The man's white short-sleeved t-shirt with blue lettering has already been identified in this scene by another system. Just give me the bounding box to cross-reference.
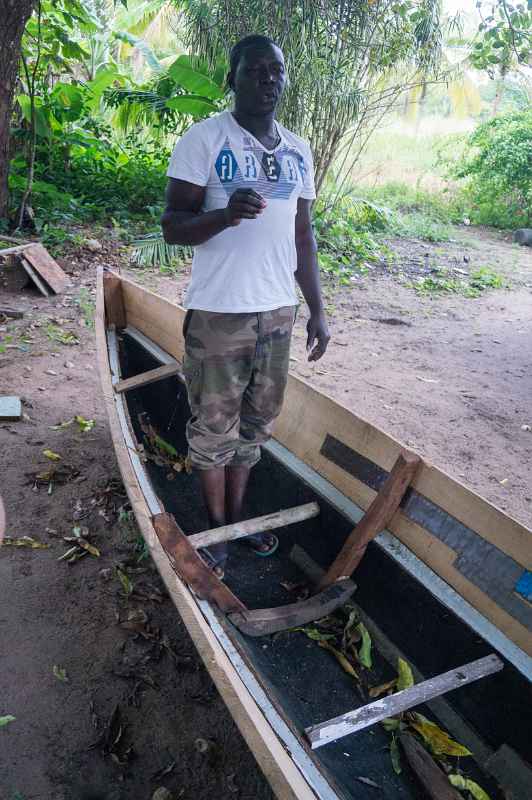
[167,111,316,314]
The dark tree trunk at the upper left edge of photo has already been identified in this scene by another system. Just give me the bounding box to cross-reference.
[0,0,35,219]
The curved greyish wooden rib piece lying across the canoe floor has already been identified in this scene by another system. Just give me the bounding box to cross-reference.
[229,579,357,636]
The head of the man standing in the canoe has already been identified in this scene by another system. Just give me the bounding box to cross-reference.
[227,34,286,115]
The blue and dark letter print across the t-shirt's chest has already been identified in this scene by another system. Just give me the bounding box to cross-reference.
[214,139,307,200]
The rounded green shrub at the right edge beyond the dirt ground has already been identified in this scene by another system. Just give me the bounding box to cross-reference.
[452,109,532,228]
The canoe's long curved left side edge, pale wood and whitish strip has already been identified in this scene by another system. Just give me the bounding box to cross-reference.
[95,269,339,800]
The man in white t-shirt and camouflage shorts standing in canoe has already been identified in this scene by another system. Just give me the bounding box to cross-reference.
[162,35,329,577]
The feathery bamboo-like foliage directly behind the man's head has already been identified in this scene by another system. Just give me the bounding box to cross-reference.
[183,0,442,189]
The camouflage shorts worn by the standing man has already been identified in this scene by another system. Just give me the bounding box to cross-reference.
[183,306,295,469]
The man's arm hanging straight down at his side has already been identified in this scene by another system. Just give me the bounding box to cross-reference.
[295,198,331,361]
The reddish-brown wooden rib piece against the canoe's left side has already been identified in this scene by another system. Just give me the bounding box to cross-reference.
[153,512,246,613]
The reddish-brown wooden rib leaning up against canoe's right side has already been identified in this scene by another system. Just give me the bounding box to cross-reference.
[319,450,422,588]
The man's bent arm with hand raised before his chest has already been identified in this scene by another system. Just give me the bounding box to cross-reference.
[161,178,266,246]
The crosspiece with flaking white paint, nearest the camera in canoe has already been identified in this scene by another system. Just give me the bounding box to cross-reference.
[305,654,504,750]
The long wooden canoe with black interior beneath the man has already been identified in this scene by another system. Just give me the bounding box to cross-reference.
[96,272,532,800]
